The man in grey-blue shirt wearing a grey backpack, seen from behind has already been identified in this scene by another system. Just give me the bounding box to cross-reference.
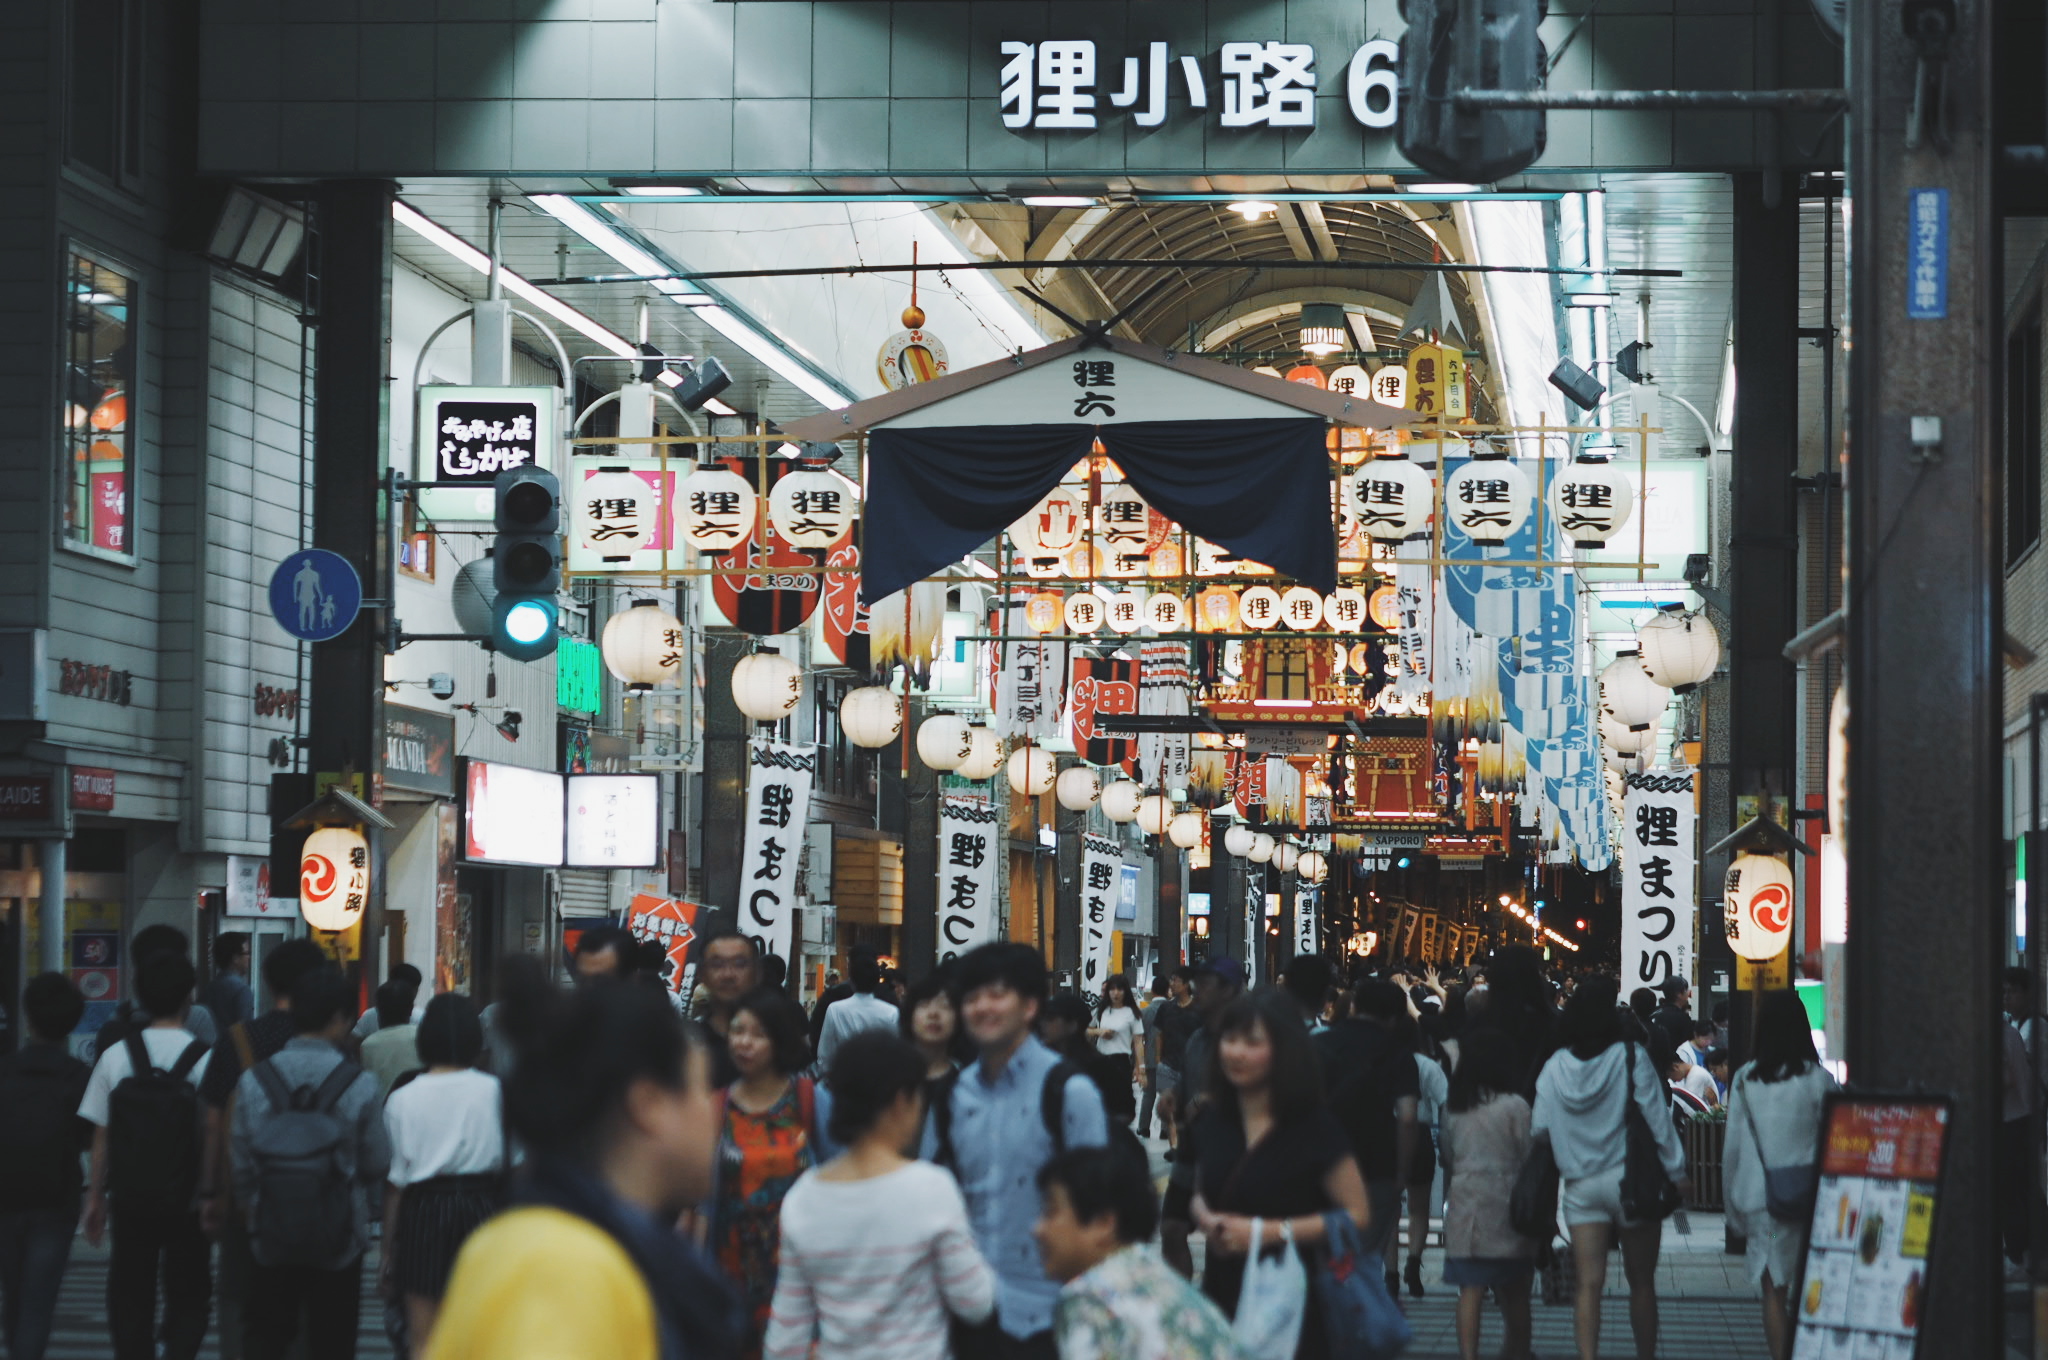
[229,965,391,1360]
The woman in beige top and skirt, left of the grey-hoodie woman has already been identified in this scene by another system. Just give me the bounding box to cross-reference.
[1442,1030,1538,1360]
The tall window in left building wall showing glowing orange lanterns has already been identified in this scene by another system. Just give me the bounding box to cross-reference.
[59,250,137,557]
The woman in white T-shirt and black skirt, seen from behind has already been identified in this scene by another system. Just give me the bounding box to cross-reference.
[381,991,512,1356]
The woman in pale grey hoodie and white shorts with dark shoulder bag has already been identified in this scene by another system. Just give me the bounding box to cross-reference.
[1530,977,1686,1360]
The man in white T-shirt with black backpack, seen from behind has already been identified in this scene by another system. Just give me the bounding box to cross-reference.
[78,950,213,1360]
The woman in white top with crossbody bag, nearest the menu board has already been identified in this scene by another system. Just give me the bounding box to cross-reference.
[1722,991,1835,1360]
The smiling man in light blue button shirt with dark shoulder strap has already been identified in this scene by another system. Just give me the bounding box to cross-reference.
[924,944,1110,1360]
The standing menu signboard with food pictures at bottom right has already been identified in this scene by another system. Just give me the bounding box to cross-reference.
[1792,1094,1950,1360]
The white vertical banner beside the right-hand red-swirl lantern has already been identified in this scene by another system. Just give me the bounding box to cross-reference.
[1622,770,1700,995]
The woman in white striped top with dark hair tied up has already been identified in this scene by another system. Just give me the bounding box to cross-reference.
[762,1030,995,1360]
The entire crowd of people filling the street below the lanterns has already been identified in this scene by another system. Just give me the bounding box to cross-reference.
[0,928,1831,1360]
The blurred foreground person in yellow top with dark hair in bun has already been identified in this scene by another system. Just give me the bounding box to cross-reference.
[426,959,745,1360]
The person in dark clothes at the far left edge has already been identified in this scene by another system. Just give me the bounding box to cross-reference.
[0,973,92,1360]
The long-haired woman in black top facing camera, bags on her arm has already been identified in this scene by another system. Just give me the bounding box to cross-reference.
[1190,993,1370,1360]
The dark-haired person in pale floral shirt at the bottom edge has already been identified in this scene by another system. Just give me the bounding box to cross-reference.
[1032,1139,1239,1360]
